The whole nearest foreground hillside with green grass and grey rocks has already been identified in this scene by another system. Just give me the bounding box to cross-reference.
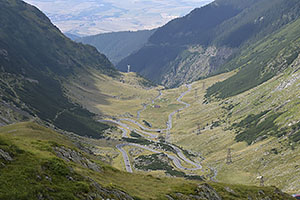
[0,123,292,200]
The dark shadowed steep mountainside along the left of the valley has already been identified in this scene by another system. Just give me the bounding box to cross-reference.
[0,0,118,137]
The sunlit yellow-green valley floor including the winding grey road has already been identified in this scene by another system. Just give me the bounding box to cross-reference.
[65,67,300,193]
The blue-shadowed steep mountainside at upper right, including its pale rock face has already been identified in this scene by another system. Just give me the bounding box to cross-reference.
[117,0,300,87]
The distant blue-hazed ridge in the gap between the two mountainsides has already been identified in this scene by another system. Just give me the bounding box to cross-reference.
[75,29,155,66]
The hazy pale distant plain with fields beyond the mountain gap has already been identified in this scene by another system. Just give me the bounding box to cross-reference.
[25,0,212,36]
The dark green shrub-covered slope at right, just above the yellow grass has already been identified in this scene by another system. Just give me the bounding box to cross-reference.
[206,14,300,99]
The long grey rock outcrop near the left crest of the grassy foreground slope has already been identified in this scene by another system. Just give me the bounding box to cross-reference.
[54,147,101,172]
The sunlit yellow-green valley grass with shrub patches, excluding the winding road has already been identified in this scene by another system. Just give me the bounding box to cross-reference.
[61,65,300,193]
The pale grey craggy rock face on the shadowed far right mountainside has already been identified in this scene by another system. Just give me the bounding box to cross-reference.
[162,45,233,87]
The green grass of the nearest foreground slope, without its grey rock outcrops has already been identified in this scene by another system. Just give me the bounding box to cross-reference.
[0,122,288,199]
